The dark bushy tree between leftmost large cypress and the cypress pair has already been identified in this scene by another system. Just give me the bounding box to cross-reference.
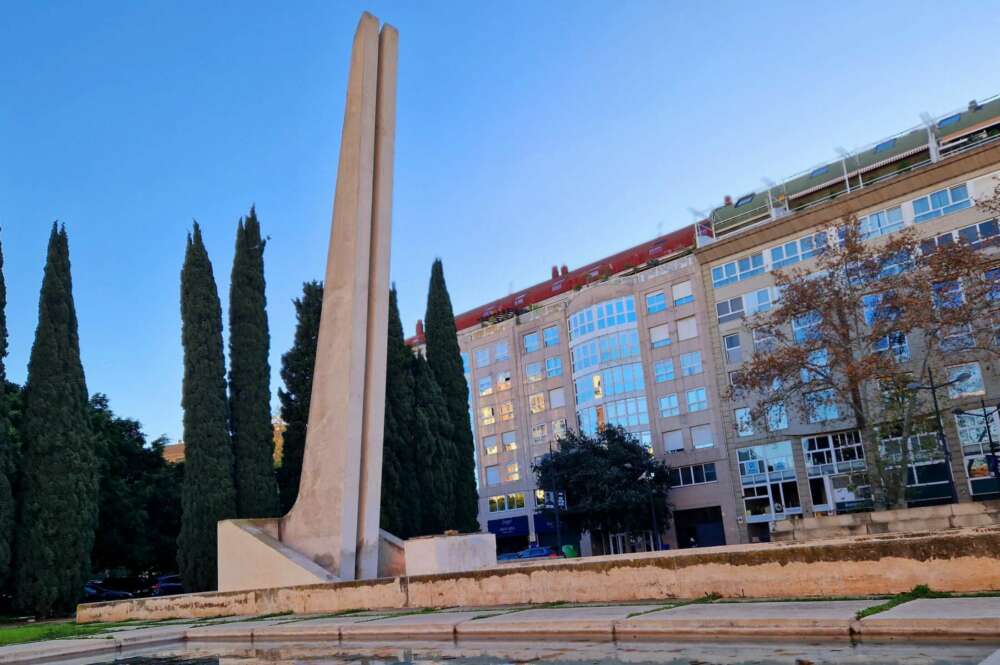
[90,393,180,575]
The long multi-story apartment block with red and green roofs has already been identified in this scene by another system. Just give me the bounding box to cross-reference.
[410,93,1000,552]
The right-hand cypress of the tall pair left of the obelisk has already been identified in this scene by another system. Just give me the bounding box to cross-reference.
[229,208,279,517]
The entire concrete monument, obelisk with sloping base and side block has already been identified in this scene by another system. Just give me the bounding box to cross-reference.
[218,12,496,591]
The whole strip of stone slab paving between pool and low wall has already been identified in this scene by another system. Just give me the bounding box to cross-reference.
[0,597,1000,663]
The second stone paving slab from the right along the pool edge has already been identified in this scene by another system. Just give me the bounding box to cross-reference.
[615,600,881,637]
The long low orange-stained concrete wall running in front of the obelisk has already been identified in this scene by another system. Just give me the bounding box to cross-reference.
[77,528,1000,623]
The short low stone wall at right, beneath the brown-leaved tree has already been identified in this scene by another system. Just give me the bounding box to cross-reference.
[772,501,1000,542]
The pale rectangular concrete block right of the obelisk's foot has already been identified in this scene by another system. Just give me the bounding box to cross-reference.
[406,533,497,576]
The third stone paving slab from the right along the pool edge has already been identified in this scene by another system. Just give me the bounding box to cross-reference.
[455,605,663,639]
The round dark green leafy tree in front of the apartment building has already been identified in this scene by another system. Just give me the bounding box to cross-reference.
[533,427,670,533]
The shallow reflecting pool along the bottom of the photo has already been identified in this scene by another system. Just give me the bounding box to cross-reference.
[74,641,1000,665]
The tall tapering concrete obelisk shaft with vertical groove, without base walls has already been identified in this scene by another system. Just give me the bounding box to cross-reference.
[279,12,399,580]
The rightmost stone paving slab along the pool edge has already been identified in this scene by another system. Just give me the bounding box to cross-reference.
[856,597,1000,639]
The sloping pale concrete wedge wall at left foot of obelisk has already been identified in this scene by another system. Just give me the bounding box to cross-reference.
[217,519,337,591]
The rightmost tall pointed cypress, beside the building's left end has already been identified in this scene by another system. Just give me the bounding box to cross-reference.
[424,259,479,532]
